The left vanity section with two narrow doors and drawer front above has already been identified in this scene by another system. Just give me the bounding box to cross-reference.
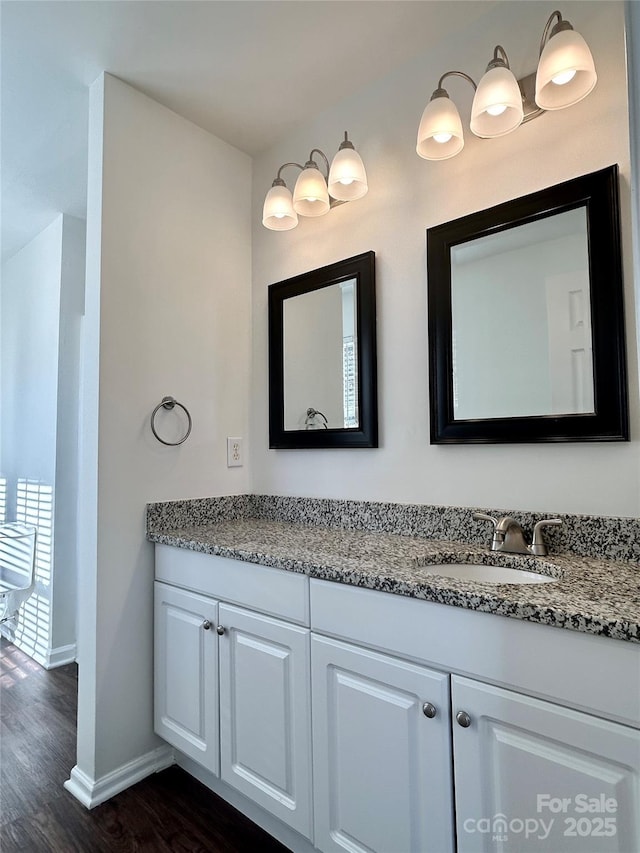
[155,546,312,838]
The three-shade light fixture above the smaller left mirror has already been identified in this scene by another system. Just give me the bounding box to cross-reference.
[262,131,369,231]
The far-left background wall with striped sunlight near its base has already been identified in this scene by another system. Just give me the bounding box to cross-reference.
[0,215,84,667]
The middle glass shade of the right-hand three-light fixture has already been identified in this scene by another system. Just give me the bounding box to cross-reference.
[470,65,524,139]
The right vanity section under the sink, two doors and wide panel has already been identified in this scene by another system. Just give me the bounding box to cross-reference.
[311,580,640,853]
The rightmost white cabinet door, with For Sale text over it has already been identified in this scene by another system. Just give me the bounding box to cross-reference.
[451,662,640,853]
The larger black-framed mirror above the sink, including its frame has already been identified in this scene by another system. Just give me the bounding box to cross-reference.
[427,166,629,444]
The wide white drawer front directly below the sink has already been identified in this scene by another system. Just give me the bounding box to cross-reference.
[310,579,640,728]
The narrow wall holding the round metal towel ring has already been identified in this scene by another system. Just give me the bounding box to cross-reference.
[75,75,251,795]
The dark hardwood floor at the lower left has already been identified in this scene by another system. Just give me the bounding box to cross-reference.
[0,639,287,853]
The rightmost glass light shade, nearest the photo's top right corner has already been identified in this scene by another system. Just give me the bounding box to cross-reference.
[536,30,598,110]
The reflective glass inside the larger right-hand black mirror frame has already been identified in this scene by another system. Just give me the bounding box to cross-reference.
[451,206,594,420]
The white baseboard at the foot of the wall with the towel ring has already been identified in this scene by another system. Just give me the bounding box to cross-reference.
[64,746,175,809]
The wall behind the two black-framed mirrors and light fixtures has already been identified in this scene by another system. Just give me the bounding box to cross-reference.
[251,2,640,516]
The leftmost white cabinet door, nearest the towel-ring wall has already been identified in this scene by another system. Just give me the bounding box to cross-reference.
[154,582,219,776]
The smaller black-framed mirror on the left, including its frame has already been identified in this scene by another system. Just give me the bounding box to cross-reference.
[269,252,378,449]
